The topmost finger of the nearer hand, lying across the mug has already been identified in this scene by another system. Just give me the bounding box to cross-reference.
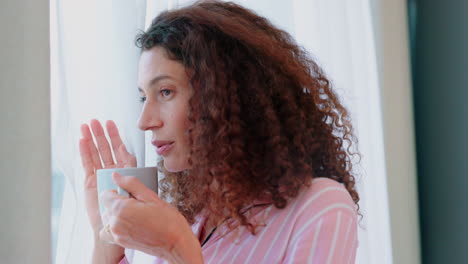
[112,172,160,202]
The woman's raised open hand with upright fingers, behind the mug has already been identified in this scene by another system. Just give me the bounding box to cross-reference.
[80,119,137,236]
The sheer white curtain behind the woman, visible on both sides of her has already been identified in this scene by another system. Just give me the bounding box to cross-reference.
[51,0,392,264]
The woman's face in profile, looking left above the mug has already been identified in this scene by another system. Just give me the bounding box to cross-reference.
[138,47,193,172]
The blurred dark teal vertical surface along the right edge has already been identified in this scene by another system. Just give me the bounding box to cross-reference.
[408,0,468,264]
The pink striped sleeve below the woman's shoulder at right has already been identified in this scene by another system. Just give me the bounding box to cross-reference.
[284,209,357,264]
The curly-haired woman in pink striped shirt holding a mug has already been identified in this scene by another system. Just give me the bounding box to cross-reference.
[80,1,359,263]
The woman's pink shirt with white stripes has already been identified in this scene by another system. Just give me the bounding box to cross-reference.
[119,178,358,264]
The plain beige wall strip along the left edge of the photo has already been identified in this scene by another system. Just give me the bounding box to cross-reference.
[0,0,51,264]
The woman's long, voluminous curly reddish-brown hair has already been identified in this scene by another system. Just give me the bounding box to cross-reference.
[136,1,359,234]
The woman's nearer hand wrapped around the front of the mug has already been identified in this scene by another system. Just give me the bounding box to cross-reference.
[100,172,203,263]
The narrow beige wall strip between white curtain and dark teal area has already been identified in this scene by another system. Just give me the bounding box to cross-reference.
[370,0,421,264]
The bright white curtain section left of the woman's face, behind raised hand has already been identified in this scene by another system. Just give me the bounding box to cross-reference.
[51,0,146,263]
